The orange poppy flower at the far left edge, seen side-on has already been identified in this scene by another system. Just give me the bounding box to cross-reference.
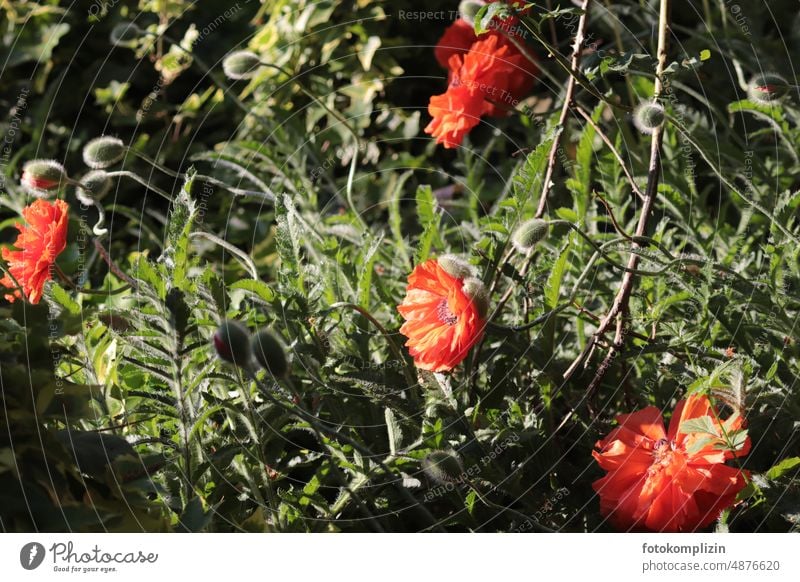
[0,200,69,303]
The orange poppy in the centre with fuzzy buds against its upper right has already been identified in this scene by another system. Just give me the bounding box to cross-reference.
[397,256,488,372]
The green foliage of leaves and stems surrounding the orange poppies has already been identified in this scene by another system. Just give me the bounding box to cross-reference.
[0,0,800,532]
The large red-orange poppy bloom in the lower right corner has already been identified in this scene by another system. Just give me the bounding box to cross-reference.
[592,394,750,532]
